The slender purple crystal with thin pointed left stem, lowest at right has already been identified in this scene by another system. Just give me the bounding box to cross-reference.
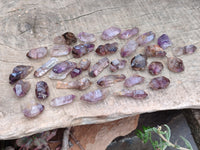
[115,89,148,99]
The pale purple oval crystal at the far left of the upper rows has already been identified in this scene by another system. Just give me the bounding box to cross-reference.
[26,47,47,59]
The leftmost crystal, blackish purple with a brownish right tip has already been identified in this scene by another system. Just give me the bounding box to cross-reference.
[9,65,33,84]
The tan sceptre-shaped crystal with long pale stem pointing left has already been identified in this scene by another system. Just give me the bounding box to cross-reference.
[56,78,92,90]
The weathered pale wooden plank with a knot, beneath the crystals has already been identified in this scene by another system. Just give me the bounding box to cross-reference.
[0,0,200,139]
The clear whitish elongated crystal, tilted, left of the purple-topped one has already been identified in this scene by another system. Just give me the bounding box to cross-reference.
[34,57,58,77]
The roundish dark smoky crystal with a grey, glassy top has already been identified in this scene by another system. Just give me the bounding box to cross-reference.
[131,54,147,71]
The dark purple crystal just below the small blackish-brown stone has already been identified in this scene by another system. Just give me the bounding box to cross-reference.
[72,43,95,58]
